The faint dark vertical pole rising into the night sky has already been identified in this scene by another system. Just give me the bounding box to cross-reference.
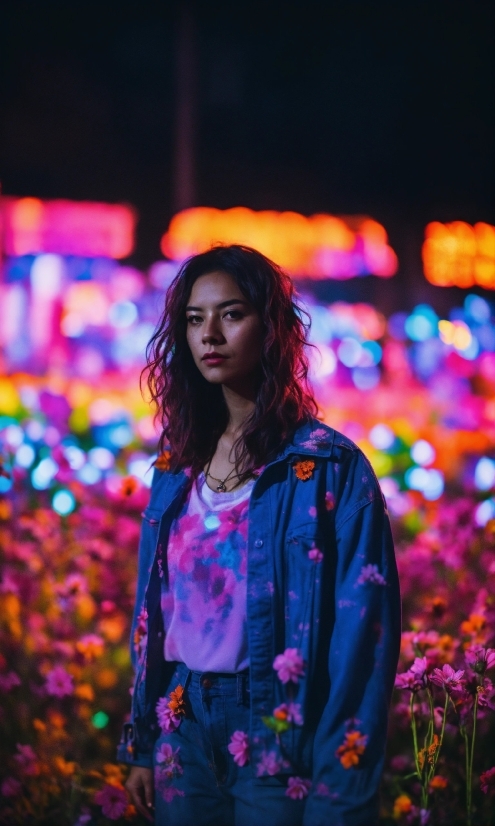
[173,0,196,212]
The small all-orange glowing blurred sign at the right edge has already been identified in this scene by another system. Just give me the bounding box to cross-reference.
[423,221,495,290]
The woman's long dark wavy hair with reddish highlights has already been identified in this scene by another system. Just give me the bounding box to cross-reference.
[142,244,317,476]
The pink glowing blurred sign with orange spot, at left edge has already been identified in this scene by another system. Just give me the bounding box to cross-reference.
[1,198,136,258]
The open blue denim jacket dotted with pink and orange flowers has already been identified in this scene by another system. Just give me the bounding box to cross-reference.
[118,420,400,826]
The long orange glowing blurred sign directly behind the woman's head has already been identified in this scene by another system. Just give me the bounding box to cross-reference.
[161,207,397,279]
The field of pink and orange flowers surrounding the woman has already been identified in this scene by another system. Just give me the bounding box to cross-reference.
[0,292,495,826]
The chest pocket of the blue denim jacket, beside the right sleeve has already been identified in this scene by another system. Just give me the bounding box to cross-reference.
[285,523,323,652]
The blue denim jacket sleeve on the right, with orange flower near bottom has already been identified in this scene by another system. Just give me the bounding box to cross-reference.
[303,454,401,826]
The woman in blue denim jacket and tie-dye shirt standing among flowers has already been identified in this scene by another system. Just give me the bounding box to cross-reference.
[119,245,400,826]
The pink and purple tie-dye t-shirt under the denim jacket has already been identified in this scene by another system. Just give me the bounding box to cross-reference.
[162,474,254,673]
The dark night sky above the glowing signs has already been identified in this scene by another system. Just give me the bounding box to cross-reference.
[0,0,495,308]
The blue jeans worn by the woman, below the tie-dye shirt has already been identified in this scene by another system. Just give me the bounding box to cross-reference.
[153,663,304,826]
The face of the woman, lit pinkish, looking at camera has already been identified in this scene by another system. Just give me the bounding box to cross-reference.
[186,270,263,393]
